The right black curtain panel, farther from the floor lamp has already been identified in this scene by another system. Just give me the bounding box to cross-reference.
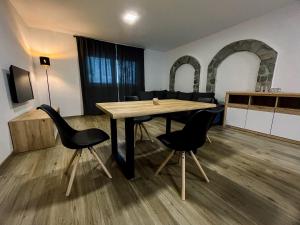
[117,45,145,101]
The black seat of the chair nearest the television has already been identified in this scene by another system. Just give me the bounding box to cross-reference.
[72,128,109,149]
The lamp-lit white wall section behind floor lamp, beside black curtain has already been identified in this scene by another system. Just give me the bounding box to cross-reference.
[28,28,83,116]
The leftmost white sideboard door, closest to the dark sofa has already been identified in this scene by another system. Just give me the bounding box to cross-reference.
[226,107,248,128]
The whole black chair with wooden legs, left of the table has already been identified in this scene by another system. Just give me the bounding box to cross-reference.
[37,104,112,197]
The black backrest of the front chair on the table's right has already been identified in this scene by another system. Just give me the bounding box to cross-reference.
[182,110,216,149]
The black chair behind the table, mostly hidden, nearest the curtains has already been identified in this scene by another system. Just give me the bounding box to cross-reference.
[125,96,153,143]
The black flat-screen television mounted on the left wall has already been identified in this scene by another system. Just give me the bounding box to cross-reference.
[8,65,34,103]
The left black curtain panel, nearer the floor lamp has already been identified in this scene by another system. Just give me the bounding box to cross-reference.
[76,36,118,115]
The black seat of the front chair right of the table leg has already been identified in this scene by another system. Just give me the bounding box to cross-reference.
[157,130,191,151]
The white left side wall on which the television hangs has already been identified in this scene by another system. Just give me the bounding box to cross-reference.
[0,1,38,163]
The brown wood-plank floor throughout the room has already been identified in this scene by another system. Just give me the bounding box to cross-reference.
[0,116,300,225]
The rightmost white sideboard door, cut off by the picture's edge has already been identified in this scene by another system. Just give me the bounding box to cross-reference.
[271,113,300,141]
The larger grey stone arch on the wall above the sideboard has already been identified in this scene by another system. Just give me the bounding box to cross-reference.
[206,39,277,92]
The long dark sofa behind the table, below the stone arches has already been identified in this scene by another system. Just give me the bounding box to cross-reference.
[138,90,224,124]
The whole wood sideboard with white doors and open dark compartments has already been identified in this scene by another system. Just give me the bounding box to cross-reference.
[224,92,300,144]
